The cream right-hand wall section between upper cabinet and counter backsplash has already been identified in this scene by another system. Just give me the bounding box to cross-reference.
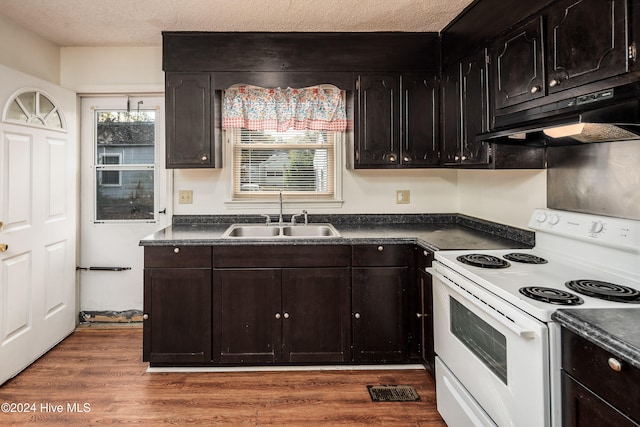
[458,170,547,229]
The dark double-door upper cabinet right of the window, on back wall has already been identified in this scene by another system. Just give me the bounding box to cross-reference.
[355,73,438,168]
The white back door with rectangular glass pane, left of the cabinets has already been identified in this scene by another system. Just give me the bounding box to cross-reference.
[80,96,171,314]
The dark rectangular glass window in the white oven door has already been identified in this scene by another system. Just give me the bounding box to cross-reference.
[449,296,507,385]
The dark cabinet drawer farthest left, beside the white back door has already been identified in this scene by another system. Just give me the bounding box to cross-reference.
[144,246,211,268]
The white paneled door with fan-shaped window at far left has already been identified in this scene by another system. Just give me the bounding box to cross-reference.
[0,67,77,384]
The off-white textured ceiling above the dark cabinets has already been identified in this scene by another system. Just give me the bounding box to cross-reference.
[0,0,472,47]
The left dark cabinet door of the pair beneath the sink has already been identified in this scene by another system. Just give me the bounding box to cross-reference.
[213,268,282,364]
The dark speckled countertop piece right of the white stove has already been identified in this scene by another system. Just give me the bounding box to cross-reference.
[551,308,640,369]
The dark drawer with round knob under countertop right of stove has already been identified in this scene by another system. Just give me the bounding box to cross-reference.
[562,328,640,422]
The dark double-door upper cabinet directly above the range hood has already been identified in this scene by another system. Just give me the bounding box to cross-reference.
[490,0,635,122]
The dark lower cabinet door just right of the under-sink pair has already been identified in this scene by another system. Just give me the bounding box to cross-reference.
[351,267,408,362]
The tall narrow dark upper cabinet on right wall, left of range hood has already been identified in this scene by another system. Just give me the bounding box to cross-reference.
[441,49,489,166]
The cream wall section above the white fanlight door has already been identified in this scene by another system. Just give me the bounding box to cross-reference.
[0,15,60,84]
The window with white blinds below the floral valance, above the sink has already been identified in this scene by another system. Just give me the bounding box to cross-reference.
[226,129,343,200]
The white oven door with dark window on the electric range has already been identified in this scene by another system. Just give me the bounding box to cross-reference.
[429,262,550,427]
